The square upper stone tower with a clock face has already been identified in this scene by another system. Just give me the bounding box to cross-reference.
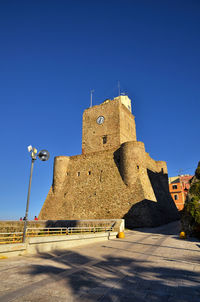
[82,95,136,154]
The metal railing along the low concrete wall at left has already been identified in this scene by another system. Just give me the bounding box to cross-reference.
[0,227,114,244]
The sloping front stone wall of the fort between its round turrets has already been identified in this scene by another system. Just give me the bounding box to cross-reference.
[39,150,142,219]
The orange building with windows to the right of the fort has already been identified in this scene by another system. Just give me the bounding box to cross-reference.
[169,175,193,211]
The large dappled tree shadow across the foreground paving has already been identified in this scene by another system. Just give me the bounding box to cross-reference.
[22,247,200,302]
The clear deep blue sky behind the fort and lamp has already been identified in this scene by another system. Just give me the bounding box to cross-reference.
[0,0,200,219]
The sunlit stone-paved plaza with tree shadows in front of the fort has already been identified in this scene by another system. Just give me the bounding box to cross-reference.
[0,222,200,302]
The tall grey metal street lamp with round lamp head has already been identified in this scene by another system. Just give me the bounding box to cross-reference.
[23,145,49,242]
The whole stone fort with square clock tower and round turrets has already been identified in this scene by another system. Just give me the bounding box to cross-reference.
[39,95,178,227]
